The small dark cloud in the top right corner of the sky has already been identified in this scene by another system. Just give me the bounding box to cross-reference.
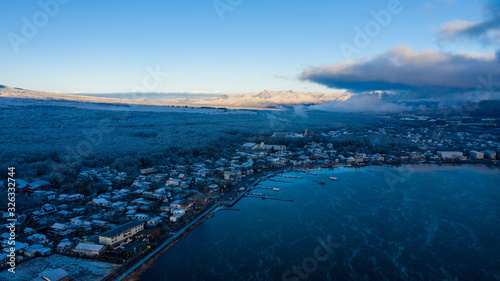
[440,0,500,44]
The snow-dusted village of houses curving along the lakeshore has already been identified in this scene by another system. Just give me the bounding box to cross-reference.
[0,118,500,280]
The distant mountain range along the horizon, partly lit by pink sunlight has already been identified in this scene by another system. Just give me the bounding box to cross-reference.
[0,85,500,117]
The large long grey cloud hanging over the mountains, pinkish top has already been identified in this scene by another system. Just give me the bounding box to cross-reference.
[300,46,500,93]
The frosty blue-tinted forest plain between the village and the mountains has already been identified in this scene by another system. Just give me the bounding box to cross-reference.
[0,103,398,186]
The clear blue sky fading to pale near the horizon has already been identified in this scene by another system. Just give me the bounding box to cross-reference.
[0,0,495,93]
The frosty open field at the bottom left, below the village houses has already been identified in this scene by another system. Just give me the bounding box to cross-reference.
[0,255,119,281]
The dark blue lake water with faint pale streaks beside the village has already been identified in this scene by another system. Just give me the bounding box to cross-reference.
[140,165,500,281]
